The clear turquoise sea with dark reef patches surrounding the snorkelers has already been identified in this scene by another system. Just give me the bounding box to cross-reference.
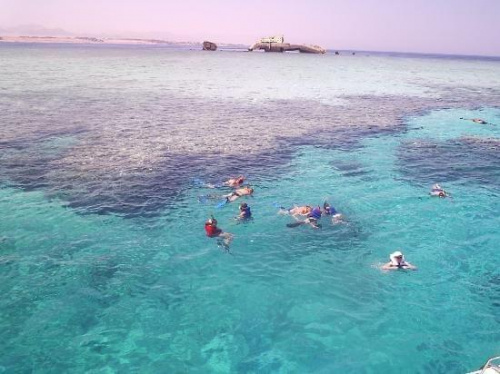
[0,43,500,374]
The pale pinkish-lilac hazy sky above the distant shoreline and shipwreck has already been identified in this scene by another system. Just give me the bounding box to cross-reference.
[0,0,500,56]
